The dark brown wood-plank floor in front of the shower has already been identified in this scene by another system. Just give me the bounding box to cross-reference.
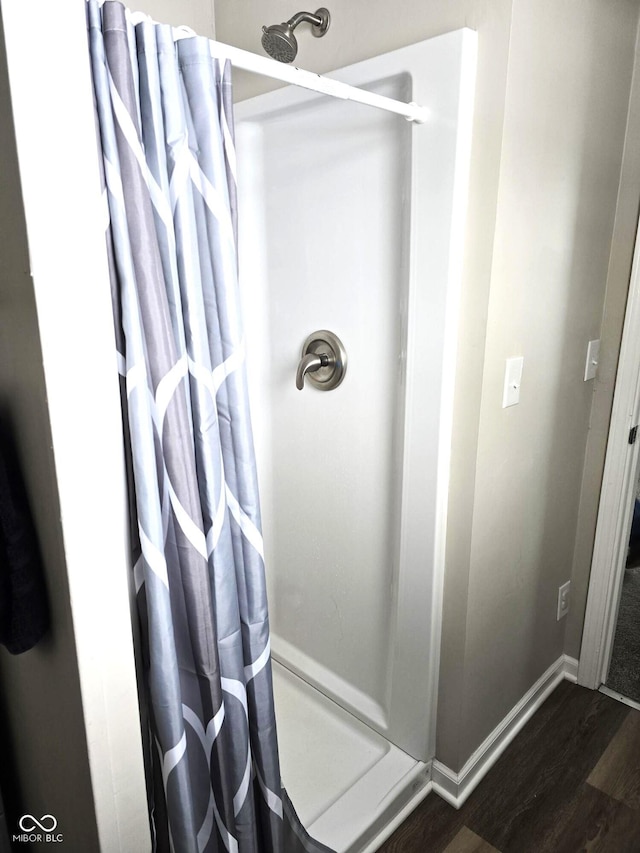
[380,681,640,853]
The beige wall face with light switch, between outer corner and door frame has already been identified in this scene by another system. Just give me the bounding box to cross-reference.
[458,0,638,761]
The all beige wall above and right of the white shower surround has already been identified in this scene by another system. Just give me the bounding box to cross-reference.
[216,0,638,770]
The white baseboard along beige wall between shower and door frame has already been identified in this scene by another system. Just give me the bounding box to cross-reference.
[431,655,578,809]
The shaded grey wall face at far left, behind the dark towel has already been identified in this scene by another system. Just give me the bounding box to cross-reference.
[0,22,97,850]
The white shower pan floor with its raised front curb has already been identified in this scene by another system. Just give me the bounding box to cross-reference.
[273,661,431,853]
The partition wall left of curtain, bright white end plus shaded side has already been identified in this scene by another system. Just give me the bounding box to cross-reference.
[0,0,150,853]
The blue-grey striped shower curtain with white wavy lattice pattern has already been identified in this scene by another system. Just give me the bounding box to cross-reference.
[87,0,336,853]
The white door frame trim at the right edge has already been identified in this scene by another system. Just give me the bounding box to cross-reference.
[578,216,640,689]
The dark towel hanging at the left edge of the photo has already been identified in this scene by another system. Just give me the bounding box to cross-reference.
[0,422,49,655]
